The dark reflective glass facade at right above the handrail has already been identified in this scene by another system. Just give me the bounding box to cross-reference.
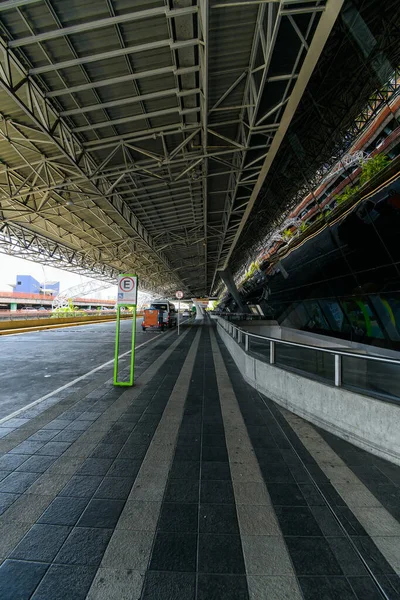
[241,176,400,350]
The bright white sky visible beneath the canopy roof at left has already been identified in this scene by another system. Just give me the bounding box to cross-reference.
[0,254,117,300]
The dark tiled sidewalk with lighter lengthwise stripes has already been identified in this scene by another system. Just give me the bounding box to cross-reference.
[0,322,400,600]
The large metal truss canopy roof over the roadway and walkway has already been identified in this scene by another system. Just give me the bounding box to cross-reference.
[0,0,342,296]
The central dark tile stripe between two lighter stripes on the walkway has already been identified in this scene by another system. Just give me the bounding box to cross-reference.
[142,328,249,600]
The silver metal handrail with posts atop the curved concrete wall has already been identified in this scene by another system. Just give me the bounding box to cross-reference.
[218,317,400,387]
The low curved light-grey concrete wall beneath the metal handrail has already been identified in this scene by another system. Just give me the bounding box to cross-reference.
[218,326,400,465]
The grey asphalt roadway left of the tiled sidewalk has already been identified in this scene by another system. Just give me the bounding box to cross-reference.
[0,319,160,419]
